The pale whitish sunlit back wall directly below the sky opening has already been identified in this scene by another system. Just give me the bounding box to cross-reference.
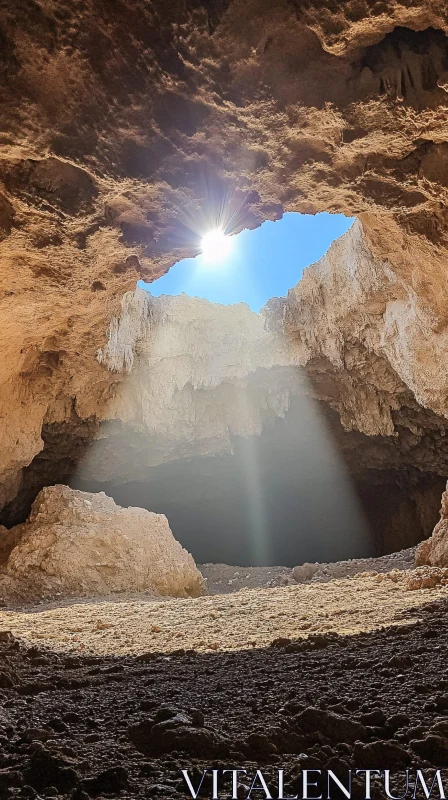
[89,289,296,472]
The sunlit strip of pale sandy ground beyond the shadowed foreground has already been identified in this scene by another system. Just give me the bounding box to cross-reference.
[0,571,448,656]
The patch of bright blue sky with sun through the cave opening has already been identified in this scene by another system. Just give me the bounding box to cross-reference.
[138,213,353,311]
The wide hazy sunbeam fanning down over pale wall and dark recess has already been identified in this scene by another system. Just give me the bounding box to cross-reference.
[72,282,372,566]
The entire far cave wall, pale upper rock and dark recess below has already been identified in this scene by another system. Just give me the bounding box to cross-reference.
[1,223,448,564]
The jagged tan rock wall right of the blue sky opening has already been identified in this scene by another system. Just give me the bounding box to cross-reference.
[263,221,448,436]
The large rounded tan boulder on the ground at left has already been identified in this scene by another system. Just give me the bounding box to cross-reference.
[0,486,203,600]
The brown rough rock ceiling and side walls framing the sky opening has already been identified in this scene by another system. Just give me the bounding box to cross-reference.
[0,0,448,564]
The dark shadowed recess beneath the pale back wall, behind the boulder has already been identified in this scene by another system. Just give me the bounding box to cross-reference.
[0,397,445,566]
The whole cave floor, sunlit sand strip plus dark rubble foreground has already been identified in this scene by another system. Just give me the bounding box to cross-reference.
[0,568,448,800]
